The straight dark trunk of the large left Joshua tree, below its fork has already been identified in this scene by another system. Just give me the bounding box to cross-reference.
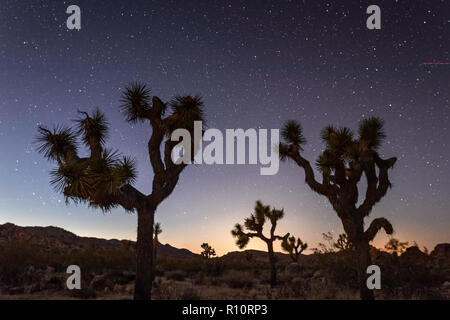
[134,206,155,300]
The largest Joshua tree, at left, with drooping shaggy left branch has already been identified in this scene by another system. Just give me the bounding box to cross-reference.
[37,83,203,300]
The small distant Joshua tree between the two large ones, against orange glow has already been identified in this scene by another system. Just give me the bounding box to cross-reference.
[231,201,289,287]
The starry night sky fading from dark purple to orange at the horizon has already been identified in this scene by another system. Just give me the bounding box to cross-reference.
[0,0,450,255]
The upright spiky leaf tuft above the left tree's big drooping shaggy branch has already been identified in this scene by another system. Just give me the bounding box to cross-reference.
[75,108,108,146]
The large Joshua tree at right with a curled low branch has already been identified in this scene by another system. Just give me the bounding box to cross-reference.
[279,118,397,299]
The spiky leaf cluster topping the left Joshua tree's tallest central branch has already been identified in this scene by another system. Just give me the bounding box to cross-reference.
[121,82,151,123]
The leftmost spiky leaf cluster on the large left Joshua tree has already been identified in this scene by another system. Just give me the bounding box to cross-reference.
[35,126,77,162]
